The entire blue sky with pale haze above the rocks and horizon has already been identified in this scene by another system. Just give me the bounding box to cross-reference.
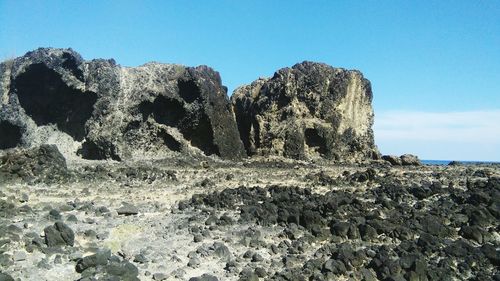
[0,0,500,161]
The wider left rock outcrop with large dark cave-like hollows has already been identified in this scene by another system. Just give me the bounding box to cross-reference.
[0,48,244,160]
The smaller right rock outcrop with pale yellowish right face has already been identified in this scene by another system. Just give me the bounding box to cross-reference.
[231,62,379,161]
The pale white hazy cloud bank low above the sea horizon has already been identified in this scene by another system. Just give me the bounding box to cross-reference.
[374,110,500,161]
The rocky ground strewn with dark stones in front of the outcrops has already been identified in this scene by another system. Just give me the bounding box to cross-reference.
[0,146,500,281]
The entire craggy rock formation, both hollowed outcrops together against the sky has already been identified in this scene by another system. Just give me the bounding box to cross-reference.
[0,48,379,161]
